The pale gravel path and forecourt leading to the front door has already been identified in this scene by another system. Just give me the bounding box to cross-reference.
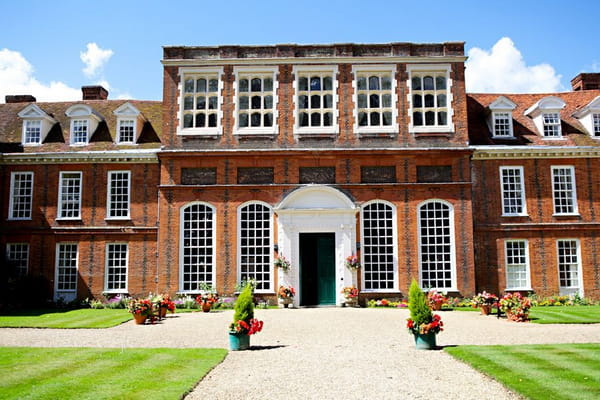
[0,308,600,400]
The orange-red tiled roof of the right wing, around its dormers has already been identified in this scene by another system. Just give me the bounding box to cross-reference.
[467,90,600,146]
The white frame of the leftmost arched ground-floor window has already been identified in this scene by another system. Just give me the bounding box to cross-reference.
[178,201,217,293]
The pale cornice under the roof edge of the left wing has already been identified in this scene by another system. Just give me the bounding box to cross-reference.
[0,149,159,164]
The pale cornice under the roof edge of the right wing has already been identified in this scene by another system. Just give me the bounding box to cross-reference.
[471,146,600,160]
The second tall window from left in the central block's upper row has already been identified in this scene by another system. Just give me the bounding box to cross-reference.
[236,69,277,133]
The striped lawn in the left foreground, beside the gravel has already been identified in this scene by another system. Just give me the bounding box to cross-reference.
[0,347,227,399]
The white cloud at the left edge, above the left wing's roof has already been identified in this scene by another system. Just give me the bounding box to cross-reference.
[0,49,81,103]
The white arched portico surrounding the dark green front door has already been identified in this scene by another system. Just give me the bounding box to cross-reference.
[274,185,359,307]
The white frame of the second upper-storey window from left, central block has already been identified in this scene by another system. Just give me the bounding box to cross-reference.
[233,66,279,136]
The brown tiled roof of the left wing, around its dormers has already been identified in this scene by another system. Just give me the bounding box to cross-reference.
[0,100,162,153]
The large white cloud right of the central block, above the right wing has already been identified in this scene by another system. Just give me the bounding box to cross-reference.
[465,37,563,93]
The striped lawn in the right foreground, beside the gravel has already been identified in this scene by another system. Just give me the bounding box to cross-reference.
[444,343,600,400]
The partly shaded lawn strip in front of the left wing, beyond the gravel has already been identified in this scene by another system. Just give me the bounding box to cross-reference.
[0,308,132,328]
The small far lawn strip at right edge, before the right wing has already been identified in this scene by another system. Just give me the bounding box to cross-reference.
[529,306,600,324]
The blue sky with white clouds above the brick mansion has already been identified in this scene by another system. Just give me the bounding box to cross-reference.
[0,0,600,101]
